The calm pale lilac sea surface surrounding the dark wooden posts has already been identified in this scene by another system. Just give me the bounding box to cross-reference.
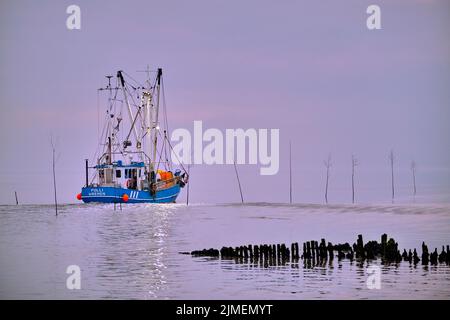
[0,203,450,299]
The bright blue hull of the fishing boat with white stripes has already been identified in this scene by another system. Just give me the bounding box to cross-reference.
[81,184,180,203]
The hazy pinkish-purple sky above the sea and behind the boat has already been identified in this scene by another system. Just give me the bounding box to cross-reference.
[0,0,450,204]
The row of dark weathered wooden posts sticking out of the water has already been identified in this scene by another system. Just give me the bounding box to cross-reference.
[182,234,450,266]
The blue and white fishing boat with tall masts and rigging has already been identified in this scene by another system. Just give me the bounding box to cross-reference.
[77,68,189,203]
